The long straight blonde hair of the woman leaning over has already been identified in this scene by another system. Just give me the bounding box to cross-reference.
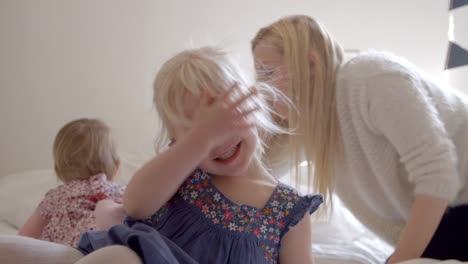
[252,15,343,205]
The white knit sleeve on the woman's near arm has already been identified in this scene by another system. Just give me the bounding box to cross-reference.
[365,72,460,202]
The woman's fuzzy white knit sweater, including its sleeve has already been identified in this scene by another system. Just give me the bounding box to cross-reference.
[335,52,468,244]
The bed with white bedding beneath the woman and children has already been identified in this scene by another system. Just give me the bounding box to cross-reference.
[0,164,459,264]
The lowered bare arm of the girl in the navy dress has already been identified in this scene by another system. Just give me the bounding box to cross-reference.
[279,213,314,264]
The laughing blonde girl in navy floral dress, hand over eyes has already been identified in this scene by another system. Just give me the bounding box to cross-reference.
[0,47,322,264]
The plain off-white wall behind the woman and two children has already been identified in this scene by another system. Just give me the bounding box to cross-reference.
[0,0,448,175]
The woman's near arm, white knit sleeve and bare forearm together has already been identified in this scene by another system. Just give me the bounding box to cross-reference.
[366,74,461,263]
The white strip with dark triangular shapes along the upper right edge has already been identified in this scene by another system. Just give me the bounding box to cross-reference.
[445,0,468,93]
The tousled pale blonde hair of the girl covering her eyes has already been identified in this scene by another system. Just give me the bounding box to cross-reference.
[153,47,284,162]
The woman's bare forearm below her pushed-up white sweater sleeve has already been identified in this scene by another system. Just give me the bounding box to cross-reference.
[388,194,447,263]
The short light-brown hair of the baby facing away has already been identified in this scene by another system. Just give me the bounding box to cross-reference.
[53,118,119,182]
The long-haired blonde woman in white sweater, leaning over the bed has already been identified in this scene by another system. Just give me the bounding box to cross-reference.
[252,16,468,263]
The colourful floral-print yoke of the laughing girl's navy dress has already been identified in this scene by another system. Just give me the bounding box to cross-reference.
[152,170,314,263]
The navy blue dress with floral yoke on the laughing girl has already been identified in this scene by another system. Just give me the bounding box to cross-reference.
[78,169,322,264]
